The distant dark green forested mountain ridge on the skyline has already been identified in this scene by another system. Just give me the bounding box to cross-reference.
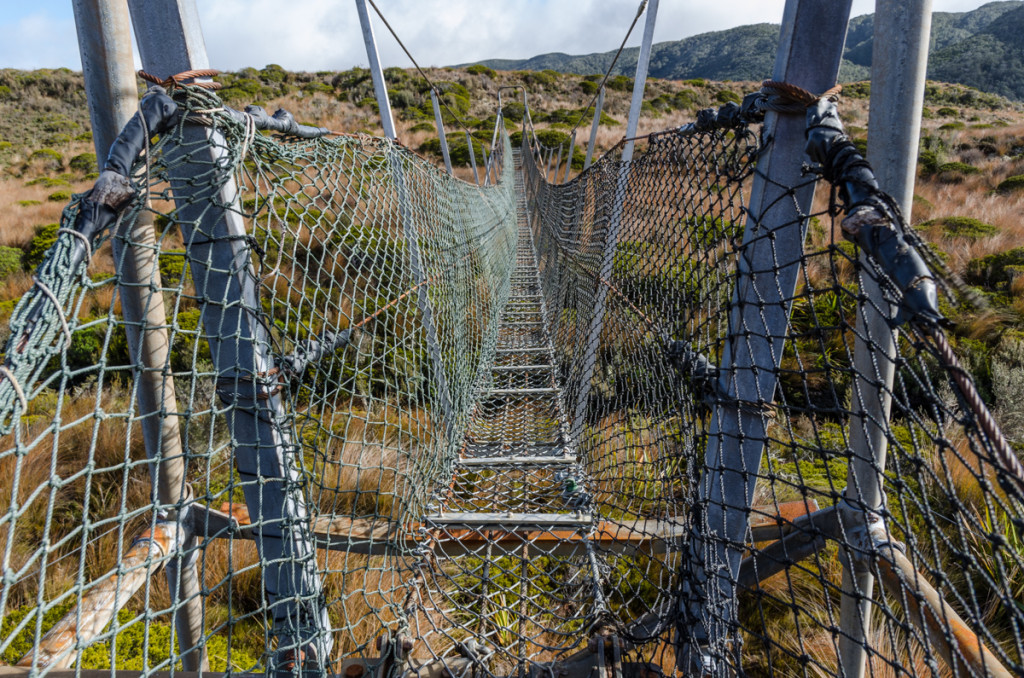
[463,0,1024,100]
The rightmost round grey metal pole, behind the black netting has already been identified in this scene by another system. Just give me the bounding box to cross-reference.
[839,0,932,678]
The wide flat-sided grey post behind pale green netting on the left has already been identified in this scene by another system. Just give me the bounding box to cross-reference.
[123,0,332,670]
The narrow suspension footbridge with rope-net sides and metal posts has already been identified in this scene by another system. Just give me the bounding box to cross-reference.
[0,0,1024,678]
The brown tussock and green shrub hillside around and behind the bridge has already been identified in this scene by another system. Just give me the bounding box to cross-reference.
[0,65,1024,670]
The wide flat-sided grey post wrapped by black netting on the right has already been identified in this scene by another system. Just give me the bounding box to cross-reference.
[679,0,852,672]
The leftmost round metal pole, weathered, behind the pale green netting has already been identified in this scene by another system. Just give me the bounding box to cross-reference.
[72,0,209,671]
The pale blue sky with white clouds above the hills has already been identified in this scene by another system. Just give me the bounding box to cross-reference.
[0,0,1003,71]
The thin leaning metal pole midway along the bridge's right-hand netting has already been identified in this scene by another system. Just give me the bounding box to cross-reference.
[571,0,658,440]
